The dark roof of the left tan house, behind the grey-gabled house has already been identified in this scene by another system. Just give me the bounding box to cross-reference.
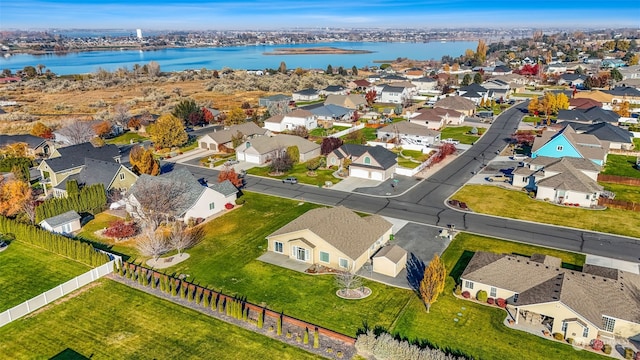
[43,142,120,172]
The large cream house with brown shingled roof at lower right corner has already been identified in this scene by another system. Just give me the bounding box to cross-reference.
[460,251,640,345]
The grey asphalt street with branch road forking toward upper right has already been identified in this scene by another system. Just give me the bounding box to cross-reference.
[177,103,640,262]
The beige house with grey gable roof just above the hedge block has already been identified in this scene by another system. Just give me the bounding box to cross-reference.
[53,158,138,197]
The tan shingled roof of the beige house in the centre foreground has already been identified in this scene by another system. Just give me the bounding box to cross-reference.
[267,206,393,259]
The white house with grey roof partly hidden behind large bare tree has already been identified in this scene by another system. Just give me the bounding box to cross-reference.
[125,167,238,223]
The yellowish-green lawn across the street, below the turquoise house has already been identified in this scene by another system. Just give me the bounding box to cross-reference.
[452,185,640,237]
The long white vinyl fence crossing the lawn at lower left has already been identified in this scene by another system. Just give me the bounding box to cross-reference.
[0,256,120,327]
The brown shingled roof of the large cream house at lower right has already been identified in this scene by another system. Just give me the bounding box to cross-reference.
[461,251,640,327]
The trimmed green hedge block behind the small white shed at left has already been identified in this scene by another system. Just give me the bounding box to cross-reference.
[36,181,107,223]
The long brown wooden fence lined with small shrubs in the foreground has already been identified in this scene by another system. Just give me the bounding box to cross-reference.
[123,262,356,346]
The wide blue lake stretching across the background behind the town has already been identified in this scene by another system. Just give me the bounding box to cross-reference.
[0,41,477,75]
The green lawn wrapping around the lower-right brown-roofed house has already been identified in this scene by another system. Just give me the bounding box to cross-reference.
[390,233,603,360]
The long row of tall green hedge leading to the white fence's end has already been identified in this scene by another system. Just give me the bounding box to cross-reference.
[0,216,109,267]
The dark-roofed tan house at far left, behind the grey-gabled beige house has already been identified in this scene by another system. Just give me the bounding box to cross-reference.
[38,142,121,194]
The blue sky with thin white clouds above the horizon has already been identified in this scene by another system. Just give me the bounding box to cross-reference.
[0,0,640,30]
